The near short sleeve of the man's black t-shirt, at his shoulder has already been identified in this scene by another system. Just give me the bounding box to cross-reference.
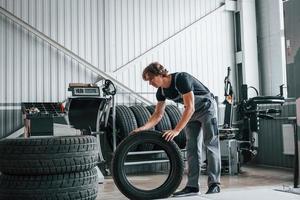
[176,72,194,94]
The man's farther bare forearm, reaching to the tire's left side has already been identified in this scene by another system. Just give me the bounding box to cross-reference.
[132,101,166,132]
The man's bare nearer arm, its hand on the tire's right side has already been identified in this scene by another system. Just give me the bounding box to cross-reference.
[163,91,195,141]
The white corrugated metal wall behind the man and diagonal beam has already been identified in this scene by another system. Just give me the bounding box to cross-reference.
[0,0,234,137]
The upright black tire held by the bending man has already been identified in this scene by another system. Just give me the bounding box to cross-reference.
[112,131,184,199]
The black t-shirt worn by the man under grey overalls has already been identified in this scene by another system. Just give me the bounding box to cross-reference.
[156,72,210,103]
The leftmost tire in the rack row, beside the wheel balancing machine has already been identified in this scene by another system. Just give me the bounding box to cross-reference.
[107,105,138,149]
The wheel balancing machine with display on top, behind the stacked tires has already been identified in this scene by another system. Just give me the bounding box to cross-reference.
[65,79,116,177]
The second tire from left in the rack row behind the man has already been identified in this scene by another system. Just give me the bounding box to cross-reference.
[130,105,154,151]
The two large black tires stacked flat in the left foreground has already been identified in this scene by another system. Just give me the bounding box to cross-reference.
[0,136,99,200]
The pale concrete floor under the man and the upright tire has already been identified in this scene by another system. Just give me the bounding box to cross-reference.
[97,166,300,200]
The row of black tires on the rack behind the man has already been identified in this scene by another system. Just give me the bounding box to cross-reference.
[108,105,186,151]
